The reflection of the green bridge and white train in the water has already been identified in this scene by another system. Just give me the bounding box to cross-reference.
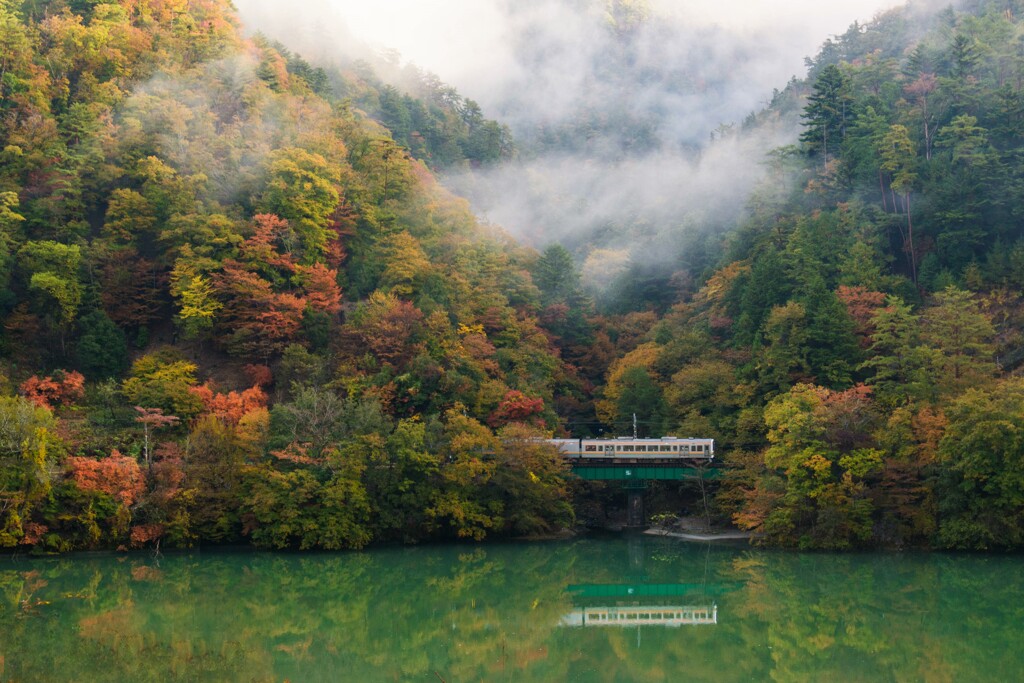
[559,584,718,628]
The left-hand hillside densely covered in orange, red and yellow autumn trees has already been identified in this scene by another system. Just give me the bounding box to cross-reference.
[0,0,578,551]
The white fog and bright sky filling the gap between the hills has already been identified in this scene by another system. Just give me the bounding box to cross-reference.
[237,0,902,288]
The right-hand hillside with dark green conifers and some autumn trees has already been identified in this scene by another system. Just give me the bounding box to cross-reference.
[598,2,1024,549]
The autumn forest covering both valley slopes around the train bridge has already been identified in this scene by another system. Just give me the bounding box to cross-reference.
[0,0,1024,553]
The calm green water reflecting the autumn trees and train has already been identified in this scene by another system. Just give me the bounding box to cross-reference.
[0,538,1024,683]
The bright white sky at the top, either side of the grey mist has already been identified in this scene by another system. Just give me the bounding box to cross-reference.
[236,0,904,103]
